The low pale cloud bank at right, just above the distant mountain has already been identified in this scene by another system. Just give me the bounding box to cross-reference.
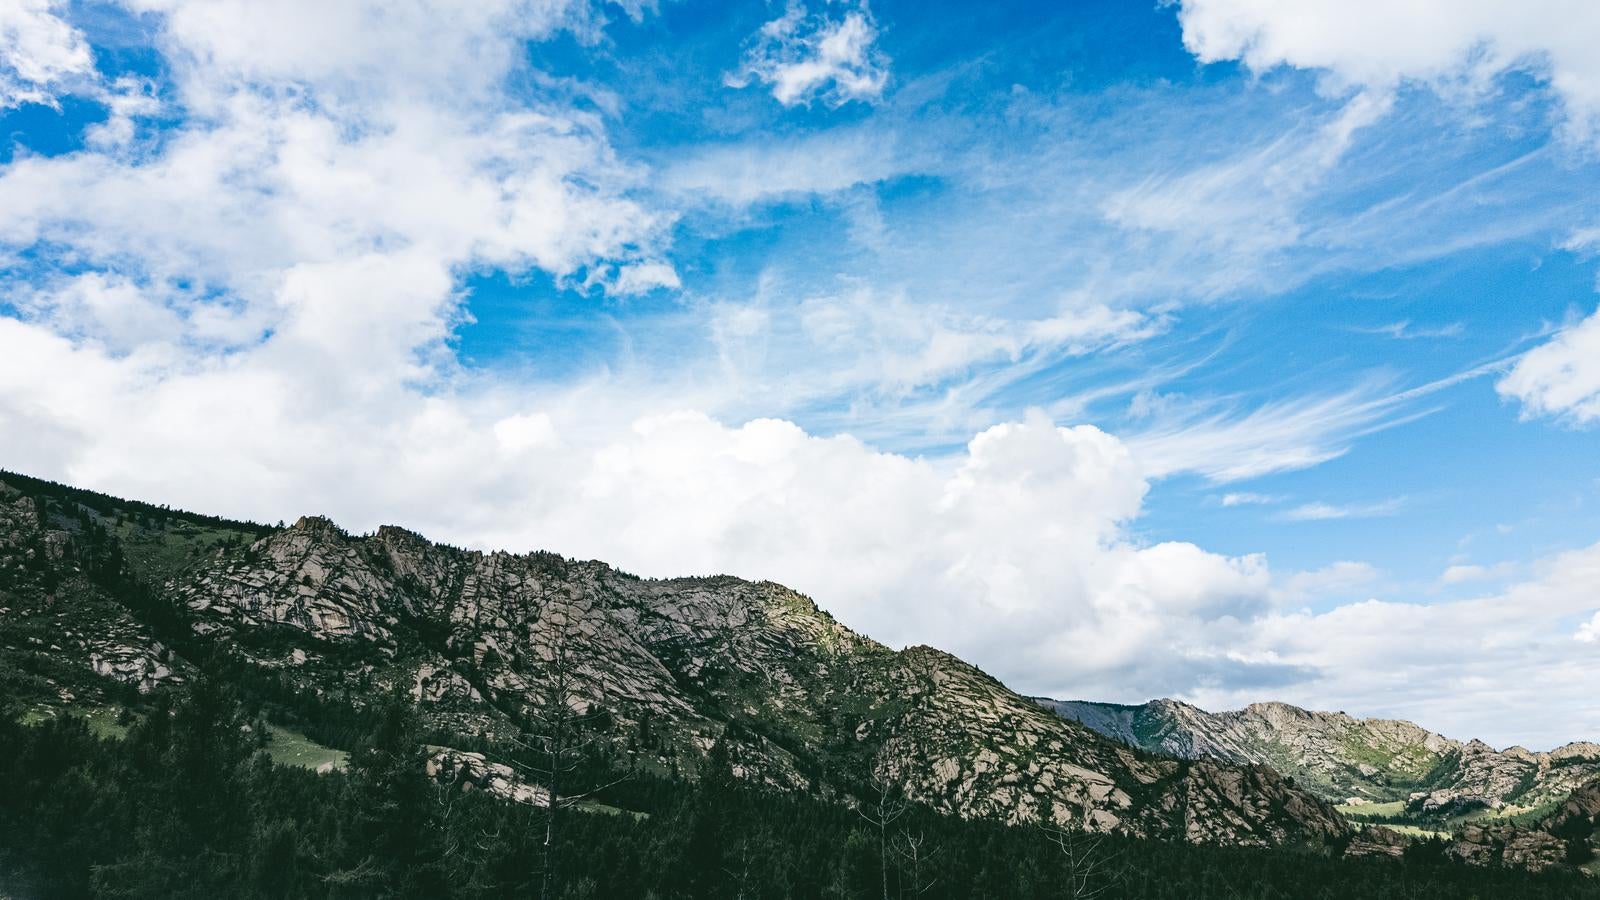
[1189,544,1600,749]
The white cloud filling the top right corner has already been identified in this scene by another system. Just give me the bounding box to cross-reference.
[1179,0,1600,139]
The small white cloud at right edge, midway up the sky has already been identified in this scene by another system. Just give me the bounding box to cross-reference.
[1494,304,1600,424]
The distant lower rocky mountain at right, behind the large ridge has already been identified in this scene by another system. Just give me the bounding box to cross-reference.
[1035,698,1600,817]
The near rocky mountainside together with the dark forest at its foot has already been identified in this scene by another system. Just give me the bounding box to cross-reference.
[0,474,1592,898]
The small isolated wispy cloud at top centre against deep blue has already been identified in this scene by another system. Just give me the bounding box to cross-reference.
[725,0,890,106]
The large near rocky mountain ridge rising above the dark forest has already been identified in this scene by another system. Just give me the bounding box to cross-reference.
[0,474,1350,846]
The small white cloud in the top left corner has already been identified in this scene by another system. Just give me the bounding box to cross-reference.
[0,0,94,109]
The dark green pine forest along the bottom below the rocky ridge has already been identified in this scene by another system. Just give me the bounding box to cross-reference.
[0,682,1600,900]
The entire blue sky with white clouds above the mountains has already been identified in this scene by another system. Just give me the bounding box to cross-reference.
[0,0,1600,749]
